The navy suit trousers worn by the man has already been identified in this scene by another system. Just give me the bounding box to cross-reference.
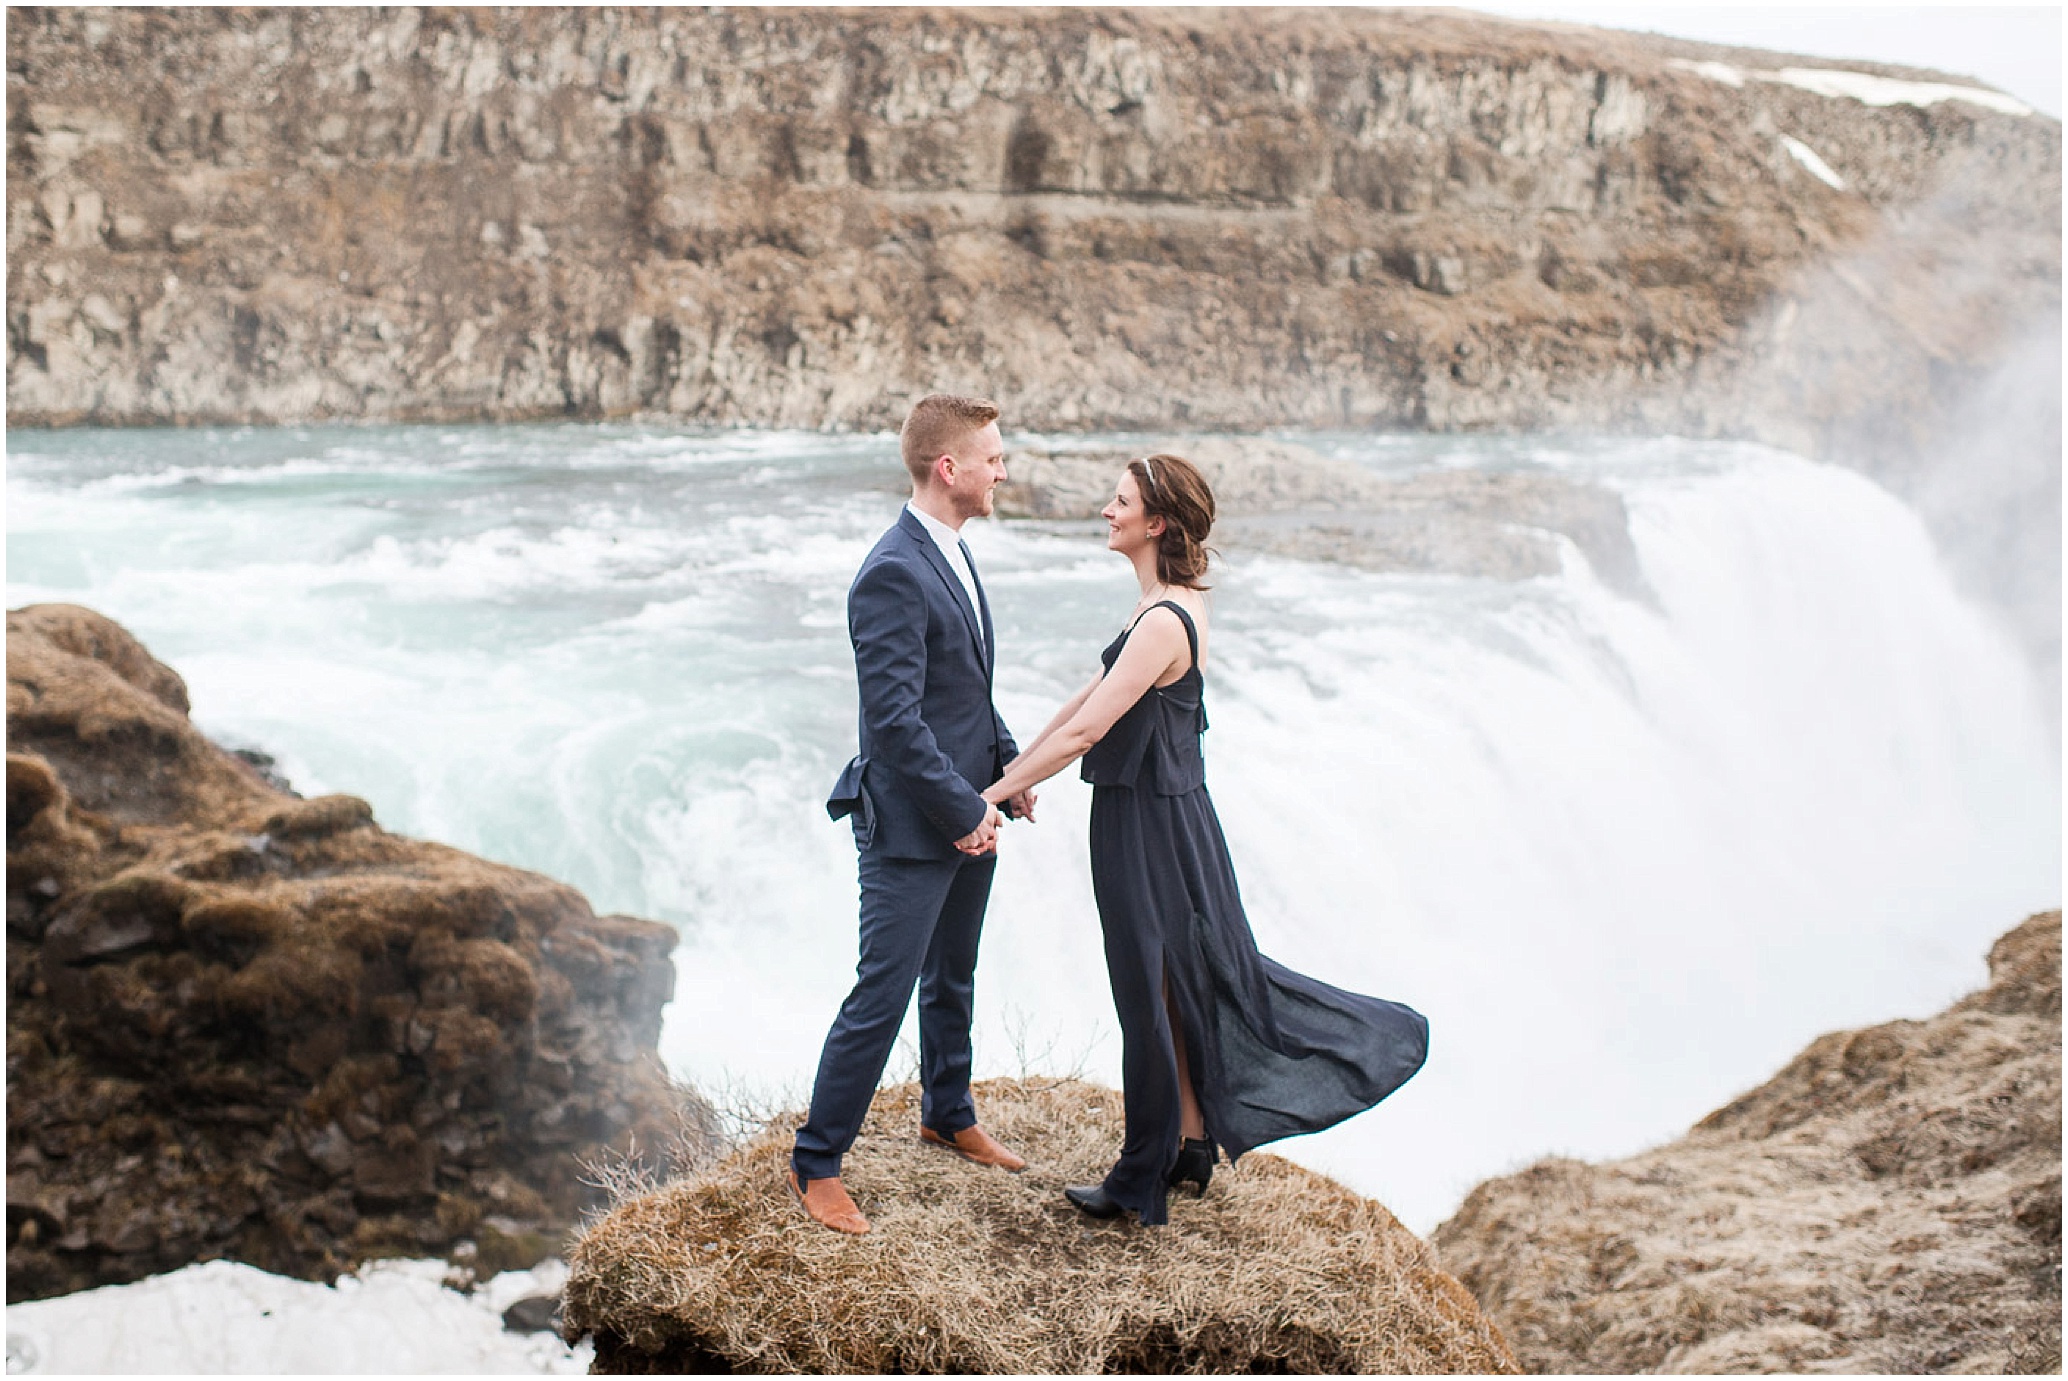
[790,850,999,1180]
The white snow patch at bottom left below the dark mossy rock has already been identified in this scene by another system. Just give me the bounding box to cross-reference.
[6,1261,594,1375]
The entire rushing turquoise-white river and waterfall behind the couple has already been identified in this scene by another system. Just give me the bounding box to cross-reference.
[8,426,2060,1230]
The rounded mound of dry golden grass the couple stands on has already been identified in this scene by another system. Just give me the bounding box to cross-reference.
[565,1079,1516,1373]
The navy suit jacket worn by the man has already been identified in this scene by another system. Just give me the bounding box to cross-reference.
[825,511,1020,858]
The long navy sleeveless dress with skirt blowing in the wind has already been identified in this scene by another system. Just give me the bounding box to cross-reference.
[1082,600,1429,1224]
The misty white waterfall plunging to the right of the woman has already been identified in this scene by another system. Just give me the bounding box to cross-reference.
[1182,455,2060,1224]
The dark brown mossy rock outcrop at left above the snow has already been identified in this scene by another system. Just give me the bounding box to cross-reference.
[6,606,674,1300]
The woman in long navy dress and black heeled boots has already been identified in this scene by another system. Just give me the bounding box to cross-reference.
[984,455,1429,1224]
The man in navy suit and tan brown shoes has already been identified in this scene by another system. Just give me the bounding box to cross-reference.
[788,393,1034,1232]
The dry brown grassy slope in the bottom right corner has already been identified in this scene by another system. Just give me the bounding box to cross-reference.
[1435,912,2062,1373]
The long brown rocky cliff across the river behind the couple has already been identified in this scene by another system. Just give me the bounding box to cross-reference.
[8,8,2060,678]
